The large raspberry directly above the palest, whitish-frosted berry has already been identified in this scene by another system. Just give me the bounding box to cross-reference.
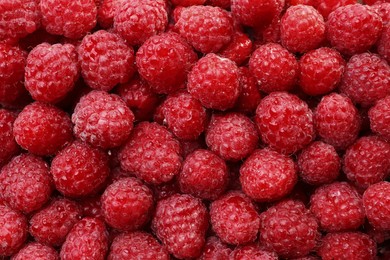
[77,30,135,91]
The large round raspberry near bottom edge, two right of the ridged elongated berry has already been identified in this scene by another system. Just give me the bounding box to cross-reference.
[260,200,320,258]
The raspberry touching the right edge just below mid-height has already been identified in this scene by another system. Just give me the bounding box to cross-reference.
[343,136,390,188]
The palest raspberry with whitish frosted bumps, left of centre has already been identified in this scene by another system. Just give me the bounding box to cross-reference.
[72,90,134,149]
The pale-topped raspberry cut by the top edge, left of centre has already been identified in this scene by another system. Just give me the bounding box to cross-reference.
[114,0,168,45]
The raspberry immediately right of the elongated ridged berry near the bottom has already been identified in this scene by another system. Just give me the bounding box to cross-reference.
[210,191,260,245]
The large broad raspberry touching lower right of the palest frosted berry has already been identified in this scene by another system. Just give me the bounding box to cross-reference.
[119,122,182,184]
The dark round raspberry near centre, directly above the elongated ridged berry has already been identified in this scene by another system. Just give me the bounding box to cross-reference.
[178,149,229,200]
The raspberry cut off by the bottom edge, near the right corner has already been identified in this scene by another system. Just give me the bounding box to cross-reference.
[318,232,377,260]
